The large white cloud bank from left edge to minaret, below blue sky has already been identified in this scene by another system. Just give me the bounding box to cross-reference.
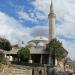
[0,11,48,44]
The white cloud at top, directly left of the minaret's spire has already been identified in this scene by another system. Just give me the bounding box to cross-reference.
[32,0,50,14]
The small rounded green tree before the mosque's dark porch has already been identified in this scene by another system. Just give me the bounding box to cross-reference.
[17,47,30,61]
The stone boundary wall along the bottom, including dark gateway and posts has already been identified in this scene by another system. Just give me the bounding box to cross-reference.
[0,65,47,75]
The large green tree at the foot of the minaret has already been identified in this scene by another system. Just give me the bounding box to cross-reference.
[46,39,68,66]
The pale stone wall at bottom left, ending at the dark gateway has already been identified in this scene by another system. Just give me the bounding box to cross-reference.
[0,66,32,75]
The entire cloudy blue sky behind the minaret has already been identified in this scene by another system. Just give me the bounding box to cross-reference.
[0,0,75,59]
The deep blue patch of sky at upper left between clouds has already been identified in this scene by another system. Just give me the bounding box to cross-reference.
[0,0,48,27]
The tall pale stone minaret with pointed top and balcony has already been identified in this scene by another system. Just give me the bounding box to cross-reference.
[48,1,56,41]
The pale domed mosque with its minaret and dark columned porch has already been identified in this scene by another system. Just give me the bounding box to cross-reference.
[27,2,56,64]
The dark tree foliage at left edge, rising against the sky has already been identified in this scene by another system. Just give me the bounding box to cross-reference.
[0,38,12,51]
